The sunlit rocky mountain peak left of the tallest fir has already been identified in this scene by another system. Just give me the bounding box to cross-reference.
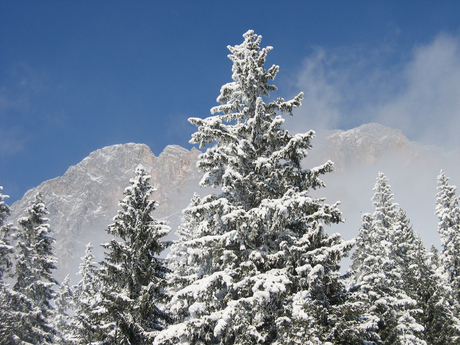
[11,143,200,280]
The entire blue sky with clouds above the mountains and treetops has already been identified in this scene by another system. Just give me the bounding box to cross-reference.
[0,0,460,202]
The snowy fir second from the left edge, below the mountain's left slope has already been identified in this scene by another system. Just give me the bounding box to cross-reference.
[11,193,58,344]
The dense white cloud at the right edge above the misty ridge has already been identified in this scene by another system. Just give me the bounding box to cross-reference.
[376,34,460,148]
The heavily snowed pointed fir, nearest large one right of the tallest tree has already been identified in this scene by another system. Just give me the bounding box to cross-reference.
[347,173,426,344]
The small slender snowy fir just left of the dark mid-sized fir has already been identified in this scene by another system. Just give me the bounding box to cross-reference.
[71,243,101,345]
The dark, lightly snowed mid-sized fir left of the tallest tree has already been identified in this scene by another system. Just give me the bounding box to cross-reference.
[93,166,170,344]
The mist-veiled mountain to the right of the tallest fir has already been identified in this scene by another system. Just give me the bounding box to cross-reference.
[306,123,460,254]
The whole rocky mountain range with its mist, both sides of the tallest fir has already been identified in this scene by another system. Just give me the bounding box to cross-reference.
[11,123,460,282]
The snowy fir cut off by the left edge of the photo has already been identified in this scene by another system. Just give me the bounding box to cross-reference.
[0,186,14,344]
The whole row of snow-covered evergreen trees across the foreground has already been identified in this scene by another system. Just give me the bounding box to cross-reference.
[0,31,460,345]
